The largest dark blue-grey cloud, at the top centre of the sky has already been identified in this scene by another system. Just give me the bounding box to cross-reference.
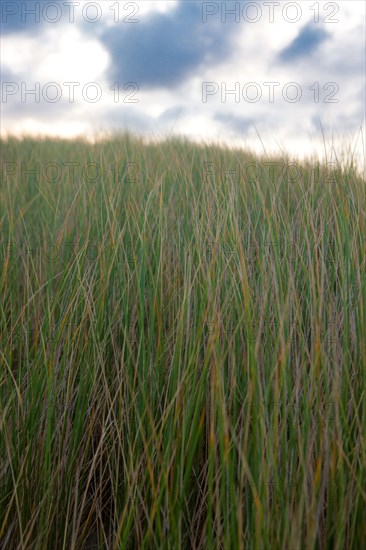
[102,2,238,88]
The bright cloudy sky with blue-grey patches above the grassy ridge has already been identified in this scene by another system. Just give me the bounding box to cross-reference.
[1,0,366,163]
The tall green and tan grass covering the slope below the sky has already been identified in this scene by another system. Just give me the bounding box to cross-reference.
[0,136,366,550]
